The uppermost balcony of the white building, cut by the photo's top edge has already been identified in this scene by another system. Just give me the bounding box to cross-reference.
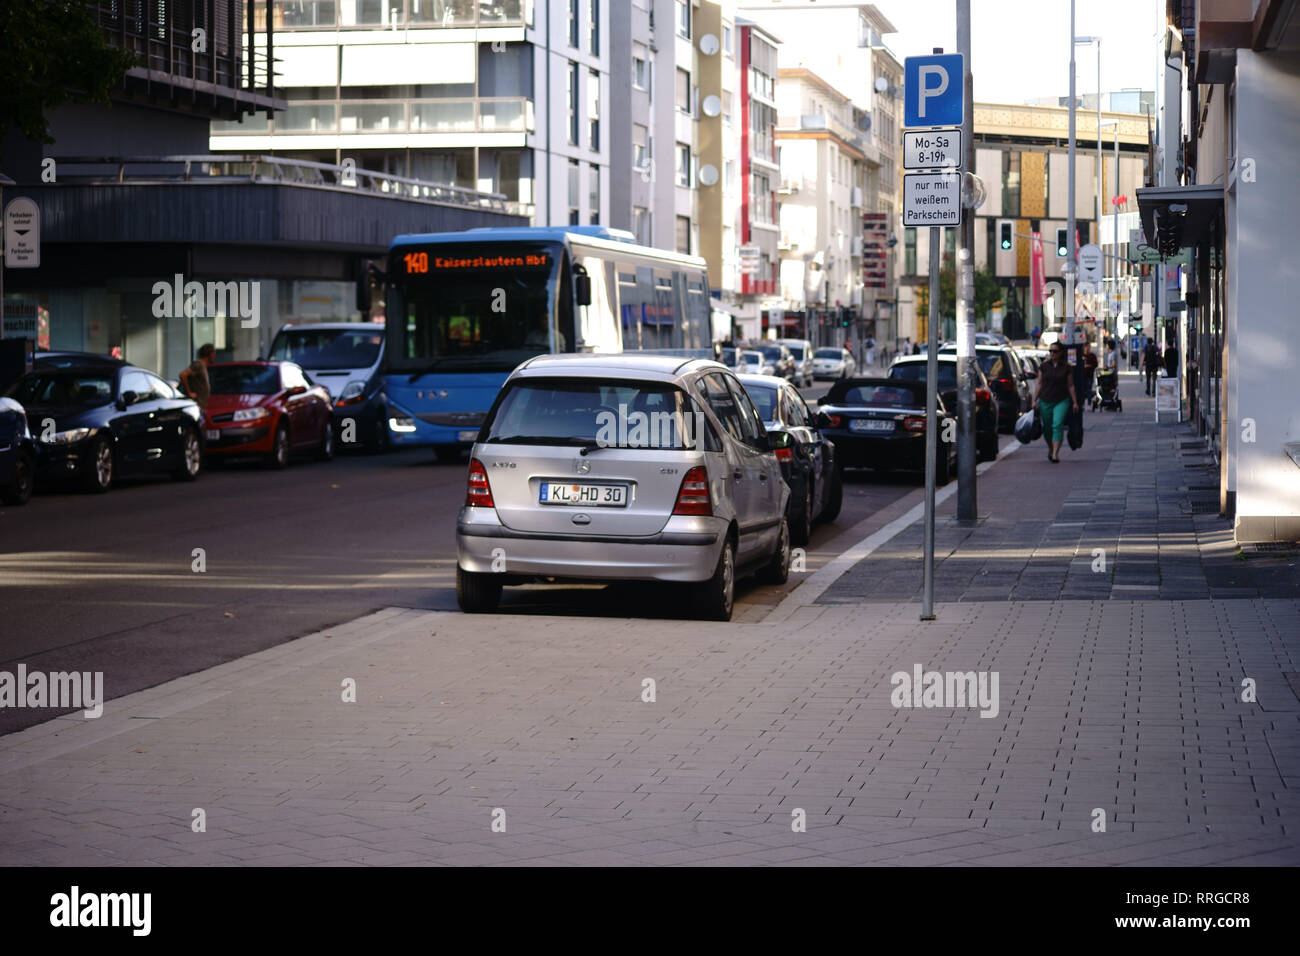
[257,0,533,31]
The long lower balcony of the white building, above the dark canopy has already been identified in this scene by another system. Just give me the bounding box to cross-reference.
[212,96,533,138]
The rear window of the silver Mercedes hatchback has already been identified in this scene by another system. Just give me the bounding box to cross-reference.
[488,378,702,450]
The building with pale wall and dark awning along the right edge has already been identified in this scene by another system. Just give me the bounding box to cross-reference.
[1138,0,1300,545]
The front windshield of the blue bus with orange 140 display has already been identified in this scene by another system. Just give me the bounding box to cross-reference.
[386,242,573,375]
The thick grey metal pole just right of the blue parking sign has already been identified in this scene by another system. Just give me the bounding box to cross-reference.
[956,0,978,522]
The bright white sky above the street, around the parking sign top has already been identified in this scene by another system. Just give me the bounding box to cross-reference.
[875,0,1165,103]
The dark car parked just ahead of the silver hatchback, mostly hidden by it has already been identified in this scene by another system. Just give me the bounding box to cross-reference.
[738,375,844,545]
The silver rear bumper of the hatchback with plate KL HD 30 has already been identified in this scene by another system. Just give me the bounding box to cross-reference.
[456,507,727,581]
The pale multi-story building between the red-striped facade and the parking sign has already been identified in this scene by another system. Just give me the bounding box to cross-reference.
[740,0,902,341]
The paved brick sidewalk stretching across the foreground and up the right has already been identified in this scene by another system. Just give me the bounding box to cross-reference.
[0,369,1300,866]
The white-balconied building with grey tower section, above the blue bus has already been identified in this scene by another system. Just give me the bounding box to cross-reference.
[212,0,611,225]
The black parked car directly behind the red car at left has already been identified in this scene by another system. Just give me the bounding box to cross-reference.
[9,362,203,492]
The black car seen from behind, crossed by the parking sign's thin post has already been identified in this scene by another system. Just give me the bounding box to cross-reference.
[818,378,957,485]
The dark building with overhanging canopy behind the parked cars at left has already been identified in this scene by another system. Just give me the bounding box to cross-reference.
[3,0,523,376]
